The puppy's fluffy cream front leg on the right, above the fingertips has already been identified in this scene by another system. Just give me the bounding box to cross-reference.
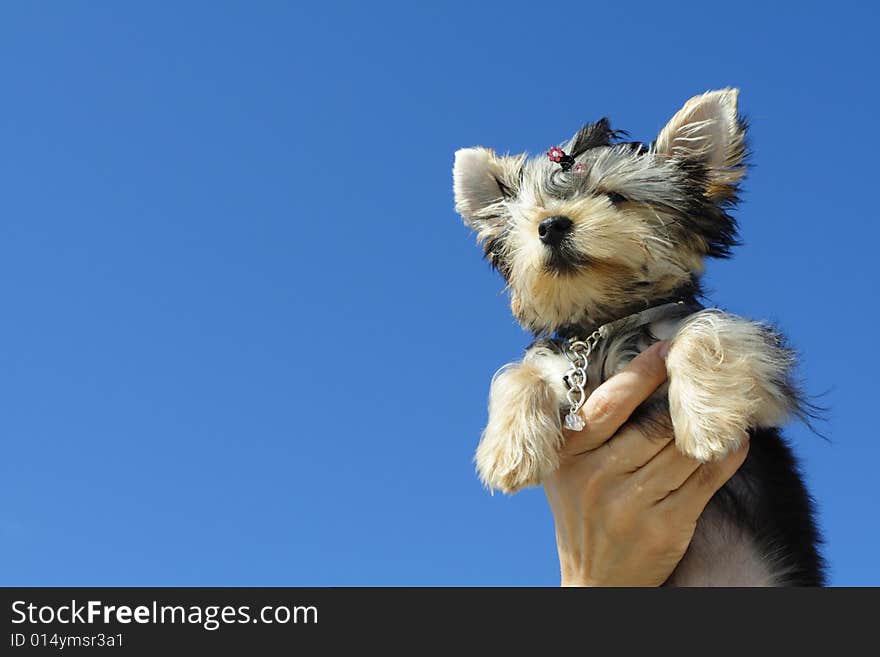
[666,310,798,461]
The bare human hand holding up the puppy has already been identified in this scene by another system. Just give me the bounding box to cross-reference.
[544,342,748,586]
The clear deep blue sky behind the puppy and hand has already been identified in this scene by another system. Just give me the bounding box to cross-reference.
[0,1,880,585]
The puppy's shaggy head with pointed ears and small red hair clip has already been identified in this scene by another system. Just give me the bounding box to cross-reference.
[453,89,745,333]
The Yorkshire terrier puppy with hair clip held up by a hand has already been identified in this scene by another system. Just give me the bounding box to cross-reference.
[453,89,824,586]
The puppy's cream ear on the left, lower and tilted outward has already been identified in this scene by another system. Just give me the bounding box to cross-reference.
[452,147,525,241]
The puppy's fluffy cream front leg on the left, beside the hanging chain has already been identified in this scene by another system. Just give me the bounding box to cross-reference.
[475,343,568,493]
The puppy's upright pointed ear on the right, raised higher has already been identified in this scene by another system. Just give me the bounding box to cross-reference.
[654,89,746,198]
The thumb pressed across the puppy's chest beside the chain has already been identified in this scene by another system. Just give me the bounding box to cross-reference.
[564,342,666,454]
